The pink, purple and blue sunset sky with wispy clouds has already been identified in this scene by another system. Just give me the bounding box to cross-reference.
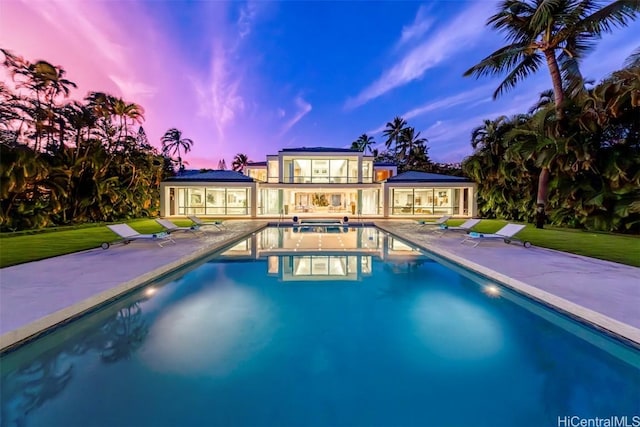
[0,0,640,168]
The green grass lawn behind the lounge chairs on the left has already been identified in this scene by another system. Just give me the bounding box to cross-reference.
[0,219,192,268]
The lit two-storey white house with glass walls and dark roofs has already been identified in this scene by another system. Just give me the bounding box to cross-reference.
[160,147,477,218]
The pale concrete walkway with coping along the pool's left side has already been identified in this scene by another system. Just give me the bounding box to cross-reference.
[0,221,267,350]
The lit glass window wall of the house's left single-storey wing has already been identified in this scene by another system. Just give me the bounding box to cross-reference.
[177,187,251,215]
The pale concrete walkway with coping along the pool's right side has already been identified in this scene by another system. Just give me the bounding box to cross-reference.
[375,221,640,344]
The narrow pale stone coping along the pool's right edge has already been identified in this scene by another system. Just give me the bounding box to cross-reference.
[375,222,640,346]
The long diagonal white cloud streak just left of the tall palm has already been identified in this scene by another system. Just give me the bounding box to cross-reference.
[345,1,493,108]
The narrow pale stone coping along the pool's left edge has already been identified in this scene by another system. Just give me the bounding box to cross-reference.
[0,221,268,355]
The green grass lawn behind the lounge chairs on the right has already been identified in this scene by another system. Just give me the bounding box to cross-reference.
[448,219,640,267]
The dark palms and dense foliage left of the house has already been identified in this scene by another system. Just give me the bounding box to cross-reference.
[0,49,192,231]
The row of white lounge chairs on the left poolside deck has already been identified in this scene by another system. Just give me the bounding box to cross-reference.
[100,216,226,249]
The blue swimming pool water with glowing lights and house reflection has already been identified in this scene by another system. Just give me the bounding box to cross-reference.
[0,227,640,427]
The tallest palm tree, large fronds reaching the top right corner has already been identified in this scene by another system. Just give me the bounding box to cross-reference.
[464,0,640,228]
